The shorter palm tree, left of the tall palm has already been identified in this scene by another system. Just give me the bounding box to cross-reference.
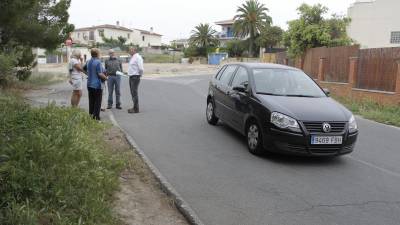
[189,23,219,55]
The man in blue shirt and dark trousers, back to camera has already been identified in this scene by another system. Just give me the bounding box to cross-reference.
[87,48,107,120]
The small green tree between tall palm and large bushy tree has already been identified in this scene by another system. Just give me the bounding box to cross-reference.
[256,26,283,48]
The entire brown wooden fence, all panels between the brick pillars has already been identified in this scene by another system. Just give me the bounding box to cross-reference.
[275,45,400,92]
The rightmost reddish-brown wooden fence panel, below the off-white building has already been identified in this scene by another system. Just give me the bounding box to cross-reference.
[356,48,400,92]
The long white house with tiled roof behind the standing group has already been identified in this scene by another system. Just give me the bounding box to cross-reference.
[71,22,162,49]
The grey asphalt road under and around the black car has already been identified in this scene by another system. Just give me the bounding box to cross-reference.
[113,76,400,225]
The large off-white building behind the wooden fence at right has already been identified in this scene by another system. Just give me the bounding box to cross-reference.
[347,0,400,48]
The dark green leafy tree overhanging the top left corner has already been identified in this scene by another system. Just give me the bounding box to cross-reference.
[0,0,74,83]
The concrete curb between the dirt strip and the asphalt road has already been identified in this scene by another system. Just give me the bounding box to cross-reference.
[109,111,204,225]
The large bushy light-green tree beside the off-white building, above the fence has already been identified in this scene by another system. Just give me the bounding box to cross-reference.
[283,4,352,57]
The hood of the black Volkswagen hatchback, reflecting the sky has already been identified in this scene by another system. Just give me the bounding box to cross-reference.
[259,95,351,121]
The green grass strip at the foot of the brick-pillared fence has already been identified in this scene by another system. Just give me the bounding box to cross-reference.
[333,96,400,127]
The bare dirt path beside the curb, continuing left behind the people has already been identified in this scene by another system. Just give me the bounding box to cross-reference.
[25,82,188,225]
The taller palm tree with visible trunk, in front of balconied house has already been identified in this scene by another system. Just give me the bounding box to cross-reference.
[234,0,272,56]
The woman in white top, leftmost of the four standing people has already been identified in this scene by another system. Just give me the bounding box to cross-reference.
[69,50,83,107]
